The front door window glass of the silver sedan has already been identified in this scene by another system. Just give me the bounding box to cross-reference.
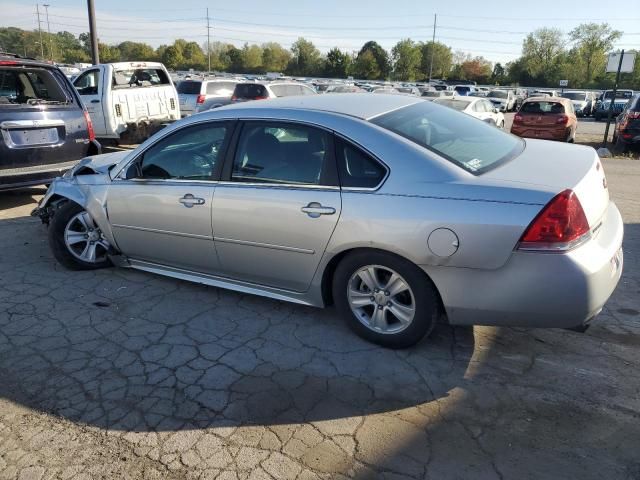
[126,123,228,180]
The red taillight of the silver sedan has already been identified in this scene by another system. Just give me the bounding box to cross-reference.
[518,190,589,251]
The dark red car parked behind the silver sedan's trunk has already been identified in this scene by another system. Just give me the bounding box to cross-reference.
[511,96,578,143]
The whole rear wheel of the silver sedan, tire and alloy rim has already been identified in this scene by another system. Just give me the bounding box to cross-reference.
[332,250,440,348]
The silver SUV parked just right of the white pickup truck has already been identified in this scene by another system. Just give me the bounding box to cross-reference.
[176,79,238,117]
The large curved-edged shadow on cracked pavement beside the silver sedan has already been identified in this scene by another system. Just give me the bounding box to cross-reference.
[0,218,475,432]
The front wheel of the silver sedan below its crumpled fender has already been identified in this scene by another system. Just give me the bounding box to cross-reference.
[48,201,111,270]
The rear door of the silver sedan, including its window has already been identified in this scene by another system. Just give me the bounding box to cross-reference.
[213,121,341,292]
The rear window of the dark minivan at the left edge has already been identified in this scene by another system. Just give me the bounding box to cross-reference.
[0,67,73,108]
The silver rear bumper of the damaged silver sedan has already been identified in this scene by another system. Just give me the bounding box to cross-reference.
[424,203,624,328]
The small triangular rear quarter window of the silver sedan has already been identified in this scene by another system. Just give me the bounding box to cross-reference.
[336,141,387,188]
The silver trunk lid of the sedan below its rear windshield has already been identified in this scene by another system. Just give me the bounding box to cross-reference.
[482,140,609,229]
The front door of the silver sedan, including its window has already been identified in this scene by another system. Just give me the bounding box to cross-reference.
[107,121,233,273]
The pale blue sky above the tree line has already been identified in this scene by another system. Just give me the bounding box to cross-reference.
[0,0,640,63]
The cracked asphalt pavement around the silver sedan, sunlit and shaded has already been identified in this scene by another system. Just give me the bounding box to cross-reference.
[0,160,640,480]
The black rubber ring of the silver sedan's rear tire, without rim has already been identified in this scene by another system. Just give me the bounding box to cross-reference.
[332,250,440,348]
